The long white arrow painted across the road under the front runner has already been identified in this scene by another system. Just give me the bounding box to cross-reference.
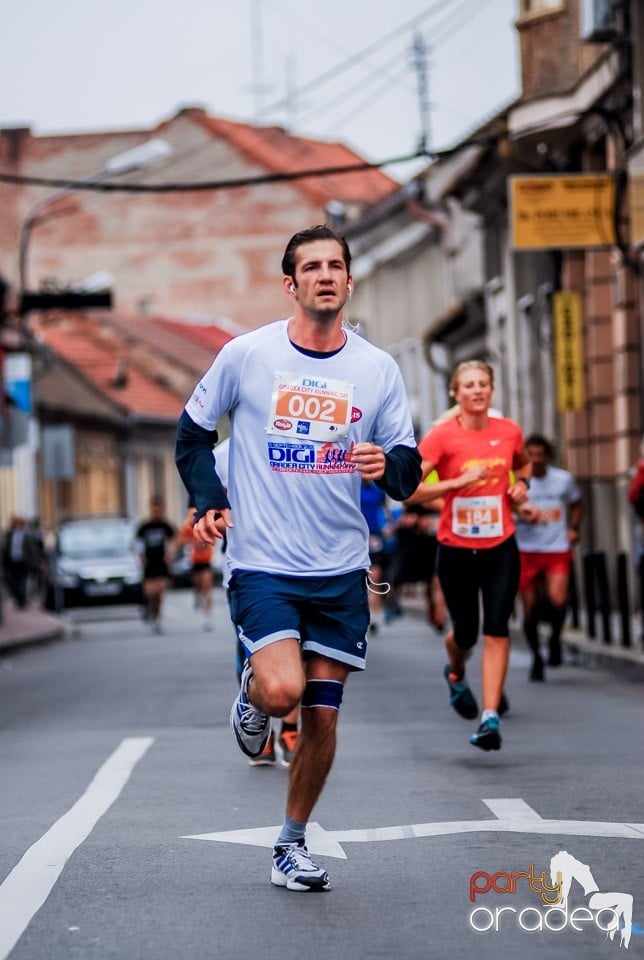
[182,799,644,860]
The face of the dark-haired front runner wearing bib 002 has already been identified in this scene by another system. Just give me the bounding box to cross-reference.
[285,240,349,320]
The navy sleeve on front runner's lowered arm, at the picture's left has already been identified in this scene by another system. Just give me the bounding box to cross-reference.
[175,410,230,520]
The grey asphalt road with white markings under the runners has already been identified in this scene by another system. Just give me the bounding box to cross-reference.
[0,592,644,960]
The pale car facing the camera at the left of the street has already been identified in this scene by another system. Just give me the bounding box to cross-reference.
[44,517,143,610]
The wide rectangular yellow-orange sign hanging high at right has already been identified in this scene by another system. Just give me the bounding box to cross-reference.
[509,173,616,250]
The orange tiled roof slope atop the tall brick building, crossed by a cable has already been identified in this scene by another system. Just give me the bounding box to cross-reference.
[190,110,400,205]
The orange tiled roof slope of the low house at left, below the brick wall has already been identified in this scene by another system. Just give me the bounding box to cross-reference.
[40,317,185,420]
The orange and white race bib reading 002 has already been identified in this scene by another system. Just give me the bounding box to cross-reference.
[266,372,353,440]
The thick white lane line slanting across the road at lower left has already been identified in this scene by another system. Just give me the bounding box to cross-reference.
[0,737,154,960]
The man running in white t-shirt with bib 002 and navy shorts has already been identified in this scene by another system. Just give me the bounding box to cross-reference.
[177,226,420,891]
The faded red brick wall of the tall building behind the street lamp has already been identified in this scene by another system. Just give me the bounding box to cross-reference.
[0,116,325,327]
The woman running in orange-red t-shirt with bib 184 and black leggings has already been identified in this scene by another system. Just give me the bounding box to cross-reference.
[408,360,531,750]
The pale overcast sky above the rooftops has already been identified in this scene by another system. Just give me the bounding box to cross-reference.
[0,0,519,173]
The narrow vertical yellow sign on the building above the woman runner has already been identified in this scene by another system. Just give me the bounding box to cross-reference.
[554,290,584,411]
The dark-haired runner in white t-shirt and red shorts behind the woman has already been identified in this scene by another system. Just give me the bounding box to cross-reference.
[516,433,583,681]
